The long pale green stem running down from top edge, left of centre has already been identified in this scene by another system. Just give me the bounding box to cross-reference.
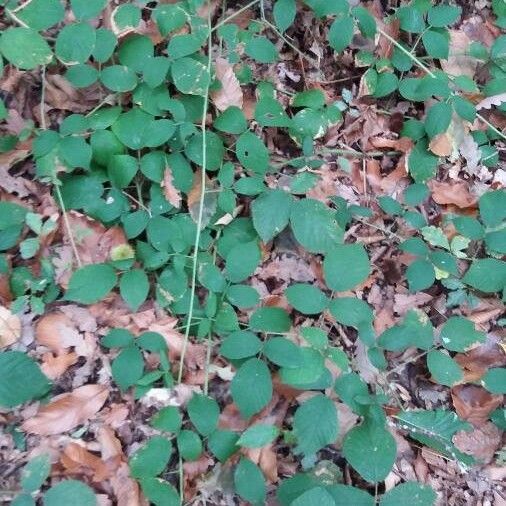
[177,0,212,383]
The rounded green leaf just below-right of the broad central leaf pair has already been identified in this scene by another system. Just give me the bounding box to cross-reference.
[323,243,371,292]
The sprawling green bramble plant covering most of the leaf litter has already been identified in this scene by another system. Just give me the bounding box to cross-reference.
[0,0,506,506]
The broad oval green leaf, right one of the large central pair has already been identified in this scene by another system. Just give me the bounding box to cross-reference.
[290,198,343,253]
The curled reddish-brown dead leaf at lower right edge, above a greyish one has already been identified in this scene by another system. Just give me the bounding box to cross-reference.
[451,385,502,427]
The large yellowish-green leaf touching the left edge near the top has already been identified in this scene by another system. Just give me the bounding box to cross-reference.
[0,27,53,70]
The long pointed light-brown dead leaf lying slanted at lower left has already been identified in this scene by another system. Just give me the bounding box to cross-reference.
[23,385,109,436]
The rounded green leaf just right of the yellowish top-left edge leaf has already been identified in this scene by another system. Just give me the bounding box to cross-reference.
[54,23,96,65]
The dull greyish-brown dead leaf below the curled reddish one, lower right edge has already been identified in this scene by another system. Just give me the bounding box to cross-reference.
[453,422,502,464]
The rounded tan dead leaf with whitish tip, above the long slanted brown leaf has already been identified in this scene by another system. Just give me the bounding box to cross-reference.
[35,313,87,356]
